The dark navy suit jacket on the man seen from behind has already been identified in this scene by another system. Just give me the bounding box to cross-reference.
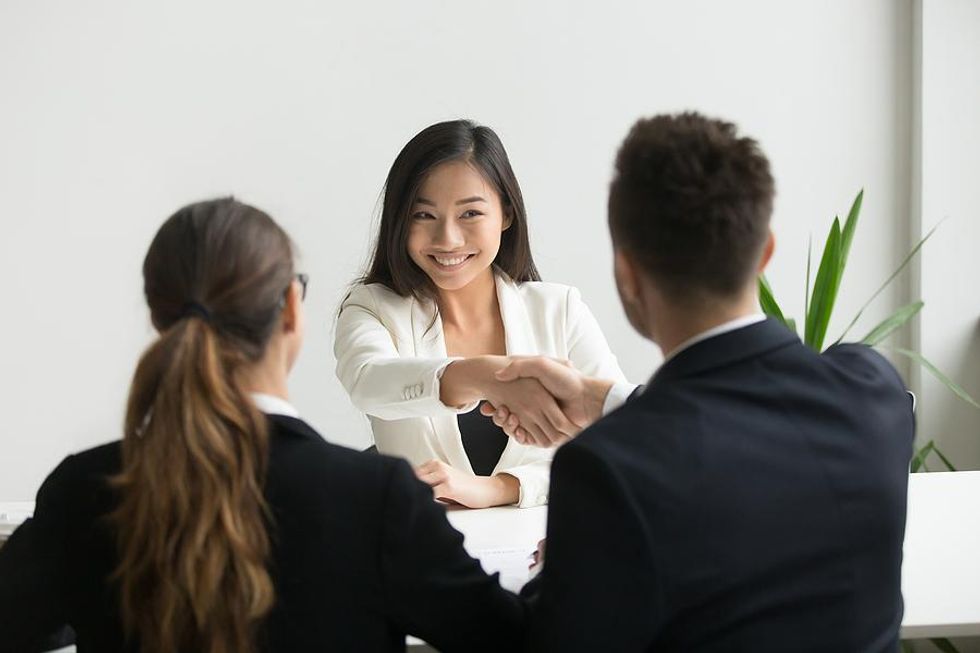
[525,321,914,653]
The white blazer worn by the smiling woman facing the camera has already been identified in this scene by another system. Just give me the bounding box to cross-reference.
[334,272,625,507]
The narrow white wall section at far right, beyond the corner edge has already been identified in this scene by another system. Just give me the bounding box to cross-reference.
[913,0,980,468]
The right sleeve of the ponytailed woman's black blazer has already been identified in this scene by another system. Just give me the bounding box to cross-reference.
[380,460,525,652]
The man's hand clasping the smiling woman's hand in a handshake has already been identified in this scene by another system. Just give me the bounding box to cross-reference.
[480,357,612,446]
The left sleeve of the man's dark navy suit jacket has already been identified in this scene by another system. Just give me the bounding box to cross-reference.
[522,442,663,652]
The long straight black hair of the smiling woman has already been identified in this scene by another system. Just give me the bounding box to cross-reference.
[360,120,541,299]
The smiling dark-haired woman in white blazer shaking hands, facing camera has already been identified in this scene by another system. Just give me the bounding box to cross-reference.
[334,120,632,508]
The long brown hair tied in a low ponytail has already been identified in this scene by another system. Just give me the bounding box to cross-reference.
[111,199,293,653]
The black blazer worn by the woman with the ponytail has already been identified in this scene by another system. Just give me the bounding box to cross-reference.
[0,416,524,653]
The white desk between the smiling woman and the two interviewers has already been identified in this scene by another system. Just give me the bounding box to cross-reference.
[0,472,980,639]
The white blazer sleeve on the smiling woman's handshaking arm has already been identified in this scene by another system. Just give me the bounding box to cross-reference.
[334,285,477,420]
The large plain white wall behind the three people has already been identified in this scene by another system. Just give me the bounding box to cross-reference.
[0,0,920,500]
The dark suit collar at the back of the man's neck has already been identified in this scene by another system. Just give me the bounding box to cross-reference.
[650,318,800,386]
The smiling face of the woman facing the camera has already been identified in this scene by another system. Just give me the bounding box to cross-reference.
[408,161,510,290]
